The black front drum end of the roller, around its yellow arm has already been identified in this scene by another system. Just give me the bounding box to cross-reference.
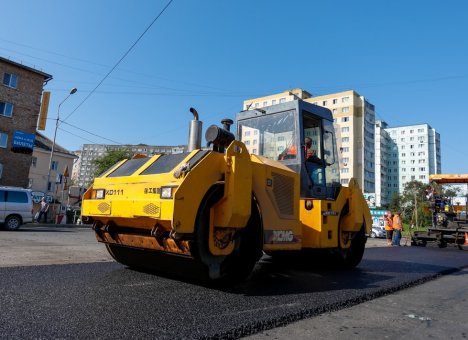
[191,186,262,284]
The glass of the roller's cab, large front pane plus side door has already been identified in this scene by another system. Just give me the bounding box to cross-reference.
[237,109,339,199]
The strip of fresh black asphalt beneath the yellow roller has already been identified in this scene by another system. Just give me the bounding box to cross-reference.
[0,224,468,339]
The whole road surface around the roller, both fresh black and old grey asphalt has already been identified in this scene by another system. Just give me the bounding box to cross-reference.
[0,225,468,339]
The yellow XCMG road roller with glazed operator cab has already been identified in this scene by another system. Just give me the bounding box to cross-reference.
[82,100,372,281]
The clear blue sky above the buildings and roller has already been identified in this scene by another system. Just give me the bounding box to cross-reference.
[0,0,468,173]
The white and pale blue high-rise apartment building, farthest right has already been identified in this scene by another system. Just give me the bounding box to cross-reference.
[385,124,442,196]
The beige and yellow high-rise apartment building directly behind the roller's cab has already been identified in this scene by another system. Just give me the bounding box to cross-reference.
[243,89,375,193]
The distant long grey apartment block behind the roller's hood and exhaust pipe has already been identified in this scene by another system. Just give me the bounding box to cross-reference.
[72,144,187,187]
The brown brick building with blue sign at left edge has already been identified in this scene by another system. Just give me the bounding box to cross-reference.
[0,57,52,187]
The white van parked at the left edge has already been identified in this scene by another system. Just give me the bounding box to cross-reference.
[0,186,33,230]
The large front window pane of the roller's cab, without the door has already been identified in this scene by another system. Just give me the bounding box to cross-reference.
[238,110,297,160]
